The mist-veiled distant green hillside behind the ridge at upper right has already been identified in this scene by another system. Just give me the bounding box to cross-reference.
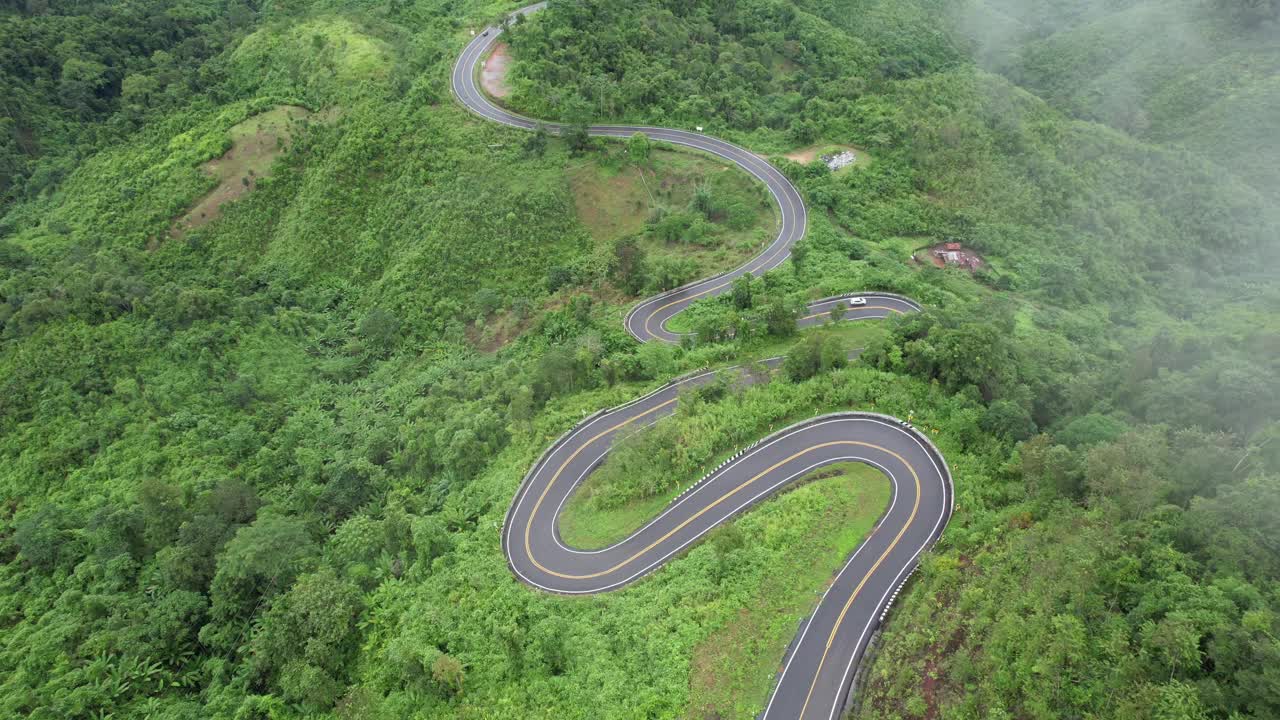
[954,0,1280,197]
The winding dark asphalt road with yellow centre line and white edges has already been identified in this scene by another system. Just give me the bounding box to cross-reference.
[453,8,954,720]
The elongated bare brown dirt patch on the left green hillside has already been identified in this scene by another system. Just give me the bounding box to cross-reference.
[169,105,329,237]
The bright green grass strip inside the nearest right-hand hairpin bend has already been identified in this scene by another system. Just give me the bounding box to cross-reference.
[686,462,890,717]
